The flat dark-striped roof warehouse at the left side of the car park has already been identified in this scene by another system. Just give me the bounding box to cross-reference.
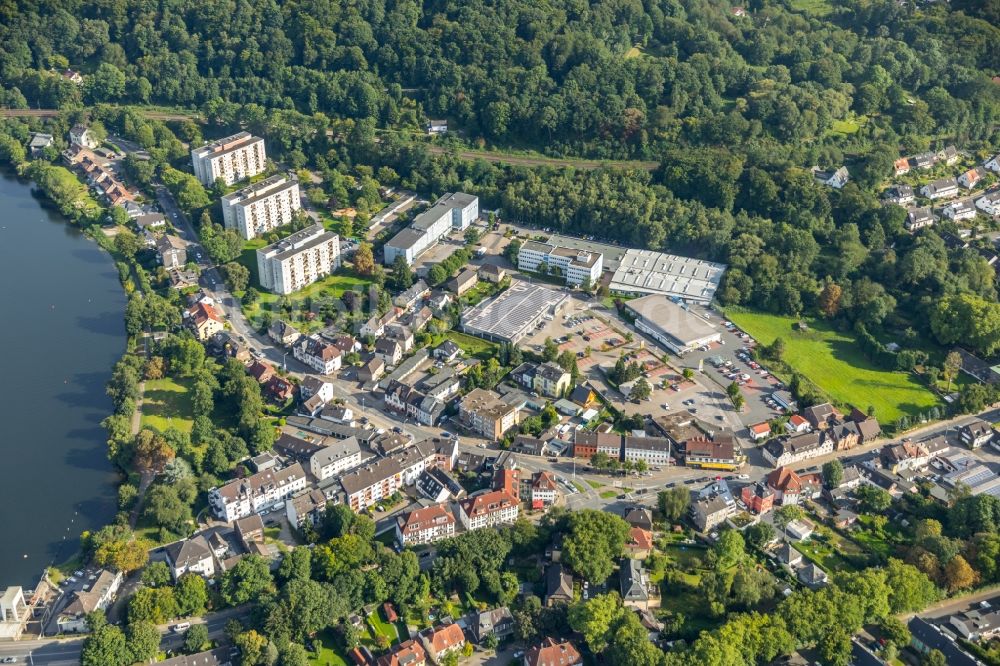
[462,281,569,342]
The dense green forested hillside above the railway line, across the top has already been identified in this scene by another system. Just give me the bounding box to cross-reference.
[0,0,1000,161]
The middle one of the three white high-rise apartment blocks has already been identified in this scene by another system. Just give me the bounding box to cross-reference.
[222,175,302,240]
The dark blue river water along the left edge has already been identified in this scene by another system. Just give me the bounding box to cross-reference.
[0,175,125,590]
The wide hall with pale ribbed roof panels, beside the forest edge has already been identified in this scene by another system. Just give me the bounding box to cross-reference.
[609,250,726,304]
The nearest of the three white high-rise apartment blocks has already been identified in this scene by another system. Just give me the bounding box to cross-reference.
[257,224,340,294]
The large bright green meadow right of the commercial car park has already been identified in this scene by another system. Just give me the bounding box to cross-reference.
[726,312,938,423]
